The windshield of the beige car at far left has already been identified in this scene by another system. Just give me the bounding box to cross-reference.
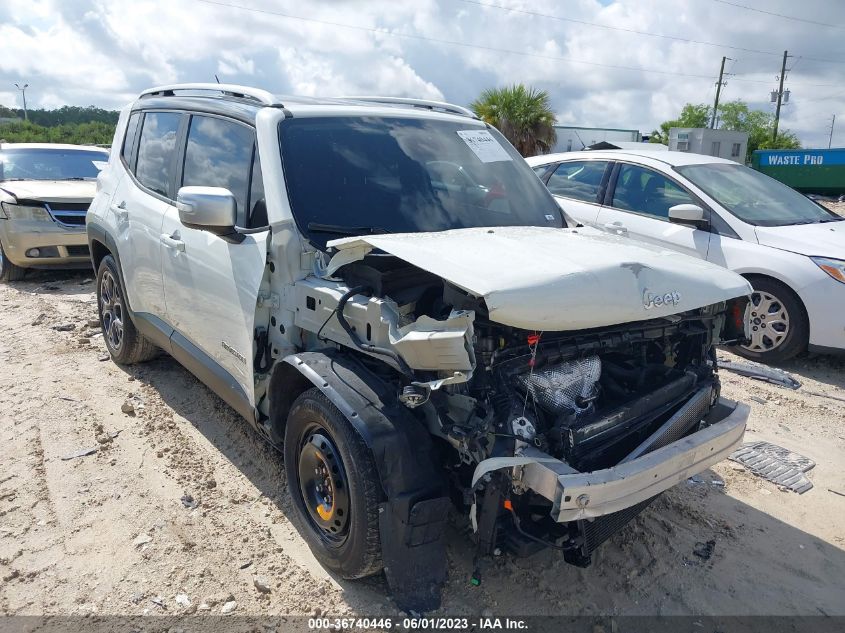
[0,148,109,181]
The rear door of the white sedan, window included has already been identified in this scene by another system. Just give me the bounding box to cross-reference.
[546,160,610,226]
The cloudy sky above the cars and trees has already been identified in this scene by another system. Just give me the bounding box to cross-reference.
[0,0,845,147]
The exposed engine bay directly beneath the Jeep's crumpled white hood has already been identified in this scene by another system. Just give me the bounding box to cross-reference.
[326,255,738,479]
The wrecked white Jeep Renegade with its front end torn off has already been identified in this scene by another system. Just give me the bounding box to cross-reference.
[87,84,751,611]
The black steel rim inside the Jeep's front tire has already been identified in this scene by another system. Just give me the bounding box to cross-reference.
[299,425,350,543]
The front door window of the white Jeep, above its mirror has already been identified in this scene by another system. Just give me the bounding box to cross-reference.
[182,115,255,226]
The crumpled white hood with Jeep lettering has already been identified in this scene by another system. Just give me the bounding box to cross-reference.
[328,227,751,331]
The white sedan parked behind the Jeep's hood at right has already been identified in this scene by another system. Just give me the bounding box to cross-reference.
[528,150,845,362]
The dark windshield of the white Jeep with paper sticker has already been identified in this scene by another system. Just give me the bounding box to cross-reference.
[280,117,563,248]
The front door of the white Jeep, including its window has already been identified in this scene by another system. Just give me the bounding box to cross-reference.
[159,115,269,408]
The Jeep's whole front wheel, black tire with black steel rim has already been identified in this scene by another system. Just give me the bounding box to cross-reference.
[284,388,383,579]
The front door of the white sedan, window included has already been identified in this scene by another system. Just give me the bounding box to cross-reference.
[597,163,711,259]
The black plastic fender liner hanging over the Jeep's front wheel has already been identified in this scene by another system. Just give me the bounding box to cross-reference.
[270,350,450,612]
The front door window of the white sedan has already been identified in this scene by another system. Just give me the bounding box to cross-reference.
[613,165,697,218]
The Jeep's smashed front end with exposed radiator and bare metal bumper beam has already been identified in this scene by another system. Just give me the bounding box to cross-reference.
[462,300,748,566]
